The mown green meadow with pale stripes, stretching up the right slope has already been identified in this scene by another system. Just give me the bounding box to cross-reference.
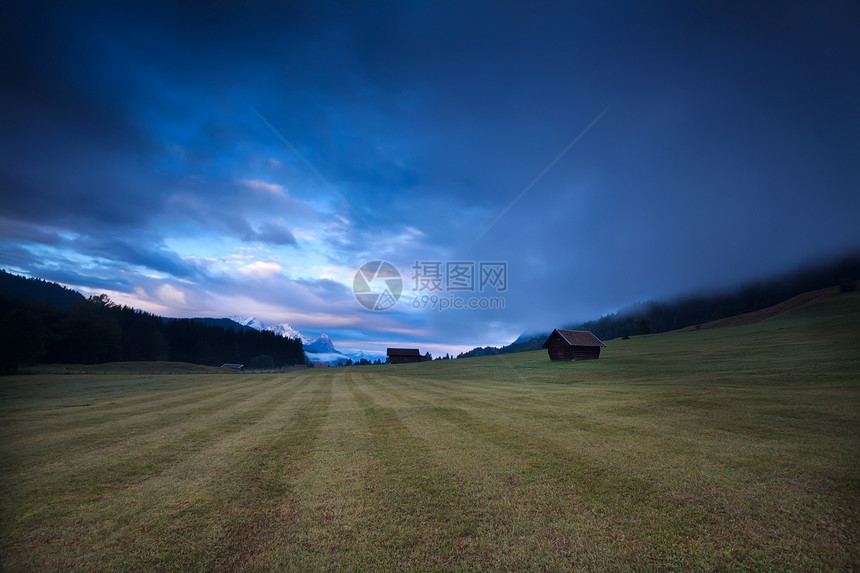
[0,294,860,571]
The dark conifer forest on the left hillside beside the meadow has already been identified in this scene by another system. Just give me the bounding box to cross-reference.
[0,284,307,374]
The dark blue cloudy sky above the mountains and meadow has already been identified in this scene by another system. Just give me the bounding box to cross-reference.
[0,0,860,353]
